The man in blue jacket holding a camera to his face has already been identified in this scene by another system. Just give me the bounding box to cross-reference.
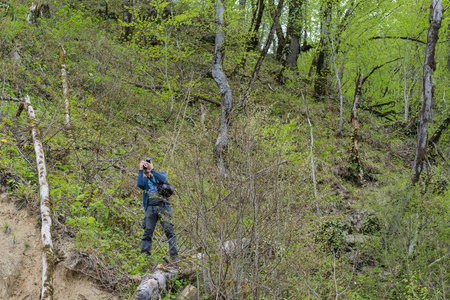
[137,157,178,263]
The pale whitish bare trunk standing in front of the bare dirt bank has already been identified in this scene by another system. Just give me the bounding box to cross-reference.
[23,95,53,300]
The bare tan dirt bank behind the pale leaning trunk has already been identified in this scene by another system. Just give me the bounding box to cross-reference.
[0,194,118,300]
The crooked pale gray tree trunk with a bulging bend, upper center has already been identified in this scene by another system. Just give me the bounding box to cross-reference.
[212,0,233,174]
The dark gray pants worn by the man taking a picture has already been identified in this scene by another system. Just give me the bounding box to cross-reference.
[141,204,178,257]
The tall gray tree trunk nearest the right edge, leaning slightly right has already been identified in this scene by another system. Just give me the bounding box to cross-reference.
[412,0,443,185]
